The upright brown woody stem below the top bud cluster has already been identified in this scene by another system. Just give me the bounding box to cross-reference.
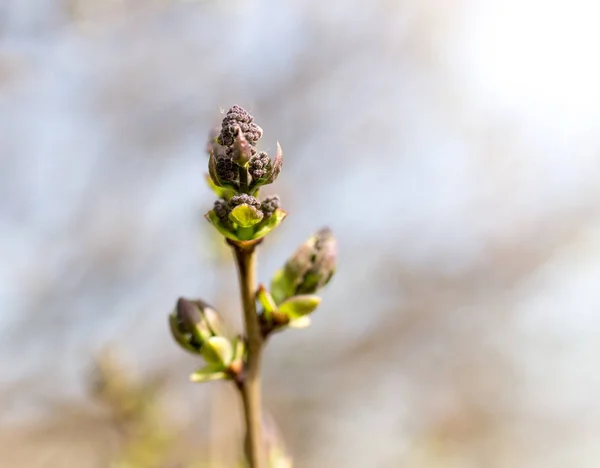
[231,242,265,468]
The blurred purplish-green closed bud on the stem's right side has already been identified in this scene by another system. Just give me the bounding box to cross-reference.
[271,228,337,304]
